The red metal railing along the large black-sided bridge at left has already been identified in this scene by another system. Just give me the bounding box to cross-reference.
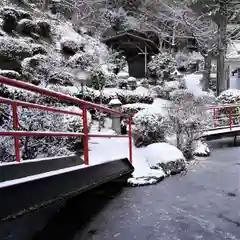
[0,76,132,165]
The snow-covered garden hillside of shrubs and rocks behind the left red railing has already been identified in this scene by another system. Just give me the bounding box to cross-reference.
[0,0,240,186]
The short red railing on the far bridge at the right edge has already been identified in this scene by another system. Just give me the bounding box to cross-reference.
[206,104,240,130]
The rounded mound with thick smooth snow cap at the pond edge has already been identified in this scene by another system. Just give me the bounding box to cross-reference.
[146,142,186,175]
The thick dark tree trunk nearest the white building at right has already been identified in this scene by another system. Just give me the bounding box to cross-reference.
[217,3,227,95]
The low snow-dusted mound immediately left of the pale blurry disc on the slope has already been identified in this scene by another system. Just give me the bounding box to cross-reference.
[48,72,74,86]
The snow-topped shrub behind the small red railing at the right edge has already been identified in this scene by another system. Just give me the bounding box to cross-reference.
[216,89,240,126]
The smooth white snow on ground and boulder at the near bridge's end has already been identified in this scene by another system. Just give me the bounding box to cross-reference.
[89,129,186,186]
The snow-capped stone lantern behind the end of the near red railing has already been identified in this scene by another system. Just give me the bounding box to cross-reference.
[108,98,122,134]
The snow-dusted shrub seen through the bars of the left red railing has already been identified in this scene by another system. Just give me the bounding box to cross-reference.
[0,105,91,162]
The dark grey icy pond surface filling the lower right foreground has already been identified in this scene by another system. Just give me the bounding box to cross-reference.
[74,140,240,240]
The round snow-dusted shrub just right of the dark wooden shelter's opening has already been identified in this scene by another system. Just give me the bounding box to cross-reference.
[148,52,176,77]
